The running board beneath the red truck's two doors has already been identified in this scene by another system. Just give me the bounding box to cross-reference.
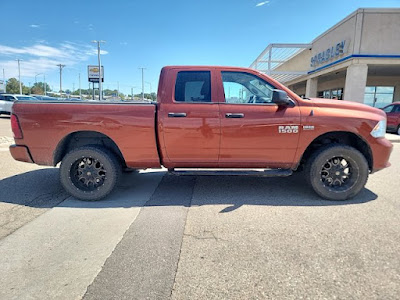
[168,168,293,177]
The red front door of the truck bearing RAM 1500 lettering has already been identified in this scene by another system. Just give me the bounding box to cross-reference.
[219,71,300,168]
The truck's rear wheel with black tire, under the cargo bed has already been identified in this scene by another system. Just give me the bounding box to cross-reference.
[60,146,121,201]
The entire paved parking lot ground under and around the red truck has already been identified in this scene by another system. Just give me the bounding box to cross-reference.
[0,118,400,299]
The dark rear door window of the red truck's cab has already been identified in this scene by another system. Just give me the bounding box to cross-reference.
[175,71,211,102]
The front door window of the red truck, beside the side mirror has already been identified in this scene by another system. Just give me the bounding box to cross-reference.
[221,72,274,104]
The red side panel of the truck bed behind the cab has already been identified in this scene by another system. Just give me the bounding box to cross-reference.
[13,101,160,168]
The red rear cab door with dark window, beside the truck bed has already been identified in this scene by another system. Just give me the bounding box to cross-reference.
[158,69,220,168]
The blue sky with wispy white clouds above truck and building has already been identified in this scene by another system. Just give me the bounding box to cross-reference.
[0,0,400,94]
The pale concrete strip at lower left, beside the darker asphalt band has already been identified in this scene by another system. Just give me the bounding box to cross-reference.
[0,172,163,299]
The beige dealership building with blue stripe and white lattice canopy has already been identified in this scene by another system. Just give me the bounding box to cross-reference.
[250,8,400,107]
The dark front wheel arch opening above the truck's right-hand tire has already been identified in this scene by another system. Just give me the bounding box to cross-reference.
[299,131,373,170]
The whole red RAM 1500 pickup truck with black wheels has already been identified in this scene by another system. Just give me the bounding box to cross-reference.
[10,66,392,200]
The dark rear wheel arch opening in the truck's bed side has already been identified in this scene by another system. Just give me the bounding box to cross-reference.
[53,131,126,166]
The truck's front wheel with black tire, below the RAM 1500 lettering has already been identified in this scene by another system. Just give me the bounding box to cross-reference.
[305,144,369,201]
